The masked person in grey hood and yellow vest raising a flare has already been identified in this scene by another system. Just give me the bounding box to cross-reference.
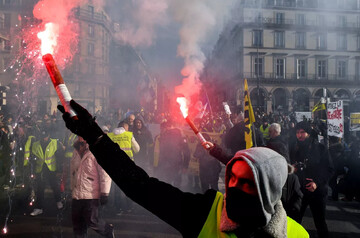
[58,100,309,238]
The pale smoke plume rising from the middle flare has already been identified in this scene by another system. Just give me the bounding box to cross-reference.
[172,0,236,103]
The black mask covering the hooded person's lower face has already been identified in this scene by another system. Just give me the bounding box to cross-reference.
[226,188,266,228]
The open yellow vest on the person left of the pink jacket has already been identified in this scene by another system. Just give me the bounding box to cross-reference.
[31,139,57,173]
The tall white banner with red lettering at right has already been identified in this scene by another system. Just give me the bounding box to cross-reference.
[327,100,344,137]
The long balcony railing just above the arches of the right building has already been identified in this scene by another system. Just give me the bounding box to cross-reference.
[243,73,359,82]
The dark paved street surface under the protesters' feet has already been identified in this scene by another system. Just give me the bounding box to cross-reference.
[0,187,360,238]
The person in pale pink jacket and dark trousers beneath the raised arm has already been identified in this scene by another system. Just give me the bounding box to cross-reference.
[70,137,115,238]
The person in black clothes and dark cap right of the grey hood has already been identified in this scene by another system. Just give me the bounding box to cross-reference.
[289,121,334,238]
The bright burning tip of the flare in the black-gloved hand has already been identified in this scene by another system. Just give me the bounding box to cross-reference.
[37,22,59,55]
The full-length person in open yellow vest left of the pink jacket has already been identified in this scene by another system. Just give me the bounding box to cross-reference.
[25,129,64,216]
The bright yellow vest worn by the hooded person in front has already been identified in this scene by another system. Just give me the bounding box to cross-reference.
[198,192,309,238]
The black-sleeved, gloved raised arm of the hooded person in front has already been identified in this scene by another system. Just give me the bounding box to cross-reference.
[58,101,216,237]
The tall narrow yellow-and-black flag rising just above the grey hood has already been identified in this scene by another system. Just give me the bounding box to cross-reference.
[244,79,255,149]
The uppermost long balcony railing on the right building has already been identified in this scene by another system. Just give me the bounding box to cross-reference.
[243,17,360,30]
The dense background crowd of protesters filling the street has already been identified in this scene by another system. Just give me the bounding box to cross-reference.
[0,102,360,237]
